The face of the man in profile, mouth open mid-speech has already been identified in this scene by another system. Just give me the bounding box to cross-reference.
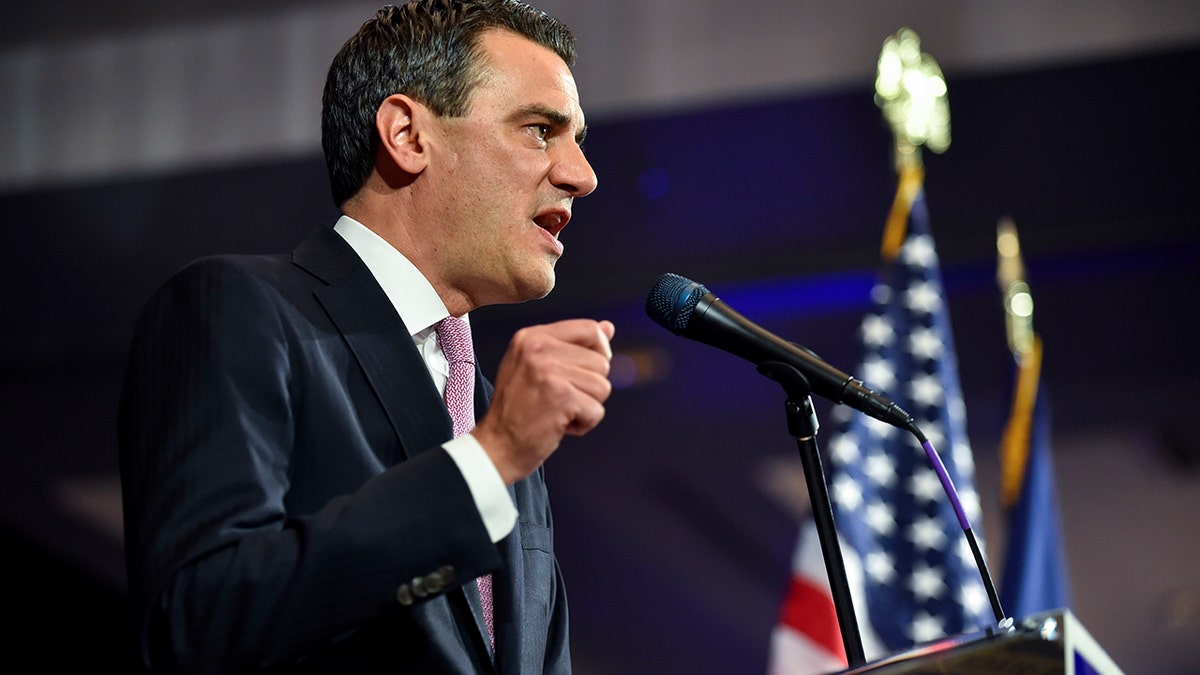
[426,30,596,307]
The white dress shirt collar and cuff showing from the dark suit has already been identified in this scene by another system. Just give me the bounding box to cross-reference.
[334,216,517,542]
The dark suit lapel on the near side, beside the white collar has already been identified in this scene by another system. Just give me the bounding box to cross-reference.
[293,228,454,459]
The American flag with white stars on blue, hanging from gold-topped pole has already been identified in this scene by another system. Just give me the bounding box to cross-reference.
[770,181,992,674]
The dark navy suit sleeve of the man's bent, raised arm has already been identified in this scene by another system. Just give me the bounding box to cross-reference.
[119,259,500,673]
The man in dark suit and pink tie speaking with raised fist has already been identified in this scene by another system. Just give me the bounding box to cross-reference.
[119,0,613,673]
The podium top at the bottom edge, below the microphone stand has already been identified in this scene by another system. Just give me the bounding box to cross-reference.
[841,610,1122,675]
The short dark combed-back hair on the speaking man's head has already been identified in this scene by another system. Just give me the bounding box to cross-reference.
[320,0,575,207]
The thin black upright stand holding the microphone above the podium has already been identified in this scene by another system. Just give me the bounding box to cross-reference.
[758,362,866,668]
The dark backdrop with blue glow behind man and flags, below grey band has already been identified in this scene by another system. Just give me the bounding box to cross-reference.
[0,7,1200,673]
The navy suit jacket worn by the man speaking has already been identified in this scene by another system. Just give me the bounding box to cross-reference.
[119,229,570,674]
